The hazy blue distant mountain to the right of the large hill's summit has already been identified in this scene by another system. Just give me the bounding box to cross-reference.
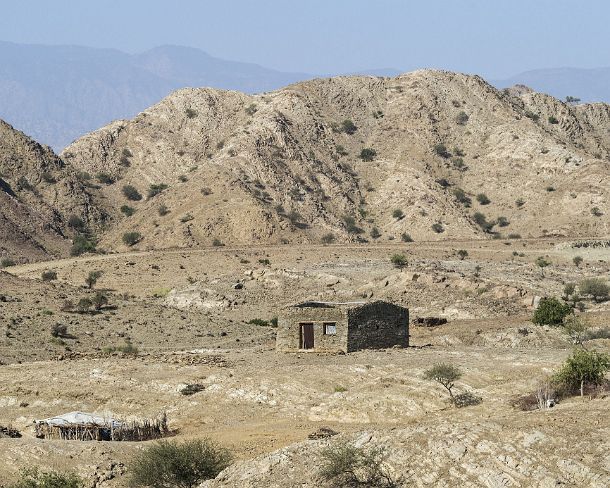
[491,68,610,103]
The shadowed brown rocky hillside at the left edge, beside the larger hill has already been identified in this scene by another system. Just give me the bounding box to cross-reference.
[0,120,101,261]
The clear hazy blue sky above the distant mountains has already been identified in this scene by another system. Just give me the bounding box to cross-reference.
[0,0,610,78]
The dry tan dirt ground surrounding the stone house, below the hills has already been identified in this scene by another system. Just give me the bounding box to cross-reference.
[0,239,610,488]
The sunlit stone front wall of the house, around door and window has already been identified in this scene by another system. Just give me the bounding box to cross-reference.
[276,307,347,352]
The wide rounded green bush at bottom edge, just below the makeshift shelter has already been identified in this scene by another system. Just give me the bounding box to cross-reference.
[130,439,231,488]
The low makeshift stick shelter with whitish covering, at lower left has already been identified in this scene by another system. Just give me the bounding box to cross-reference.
[34,412,169,441]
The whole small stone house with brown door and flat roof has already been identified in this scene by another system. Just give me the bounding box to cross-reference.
[276,301,409,352]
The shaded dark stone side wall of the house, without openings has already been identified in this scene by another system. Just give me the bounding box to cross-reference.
[347,302,409,352]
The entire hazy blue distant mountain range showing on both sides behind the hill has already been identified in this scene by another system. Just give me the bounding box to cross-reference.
[0,42,610,151]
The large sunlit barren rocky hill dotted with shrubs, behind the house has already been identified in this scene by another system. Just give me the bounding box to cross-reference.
[63,71,610,252]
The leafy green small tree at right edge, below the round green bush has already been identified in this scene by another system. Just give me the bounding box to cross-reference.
[553,348,610,397]
